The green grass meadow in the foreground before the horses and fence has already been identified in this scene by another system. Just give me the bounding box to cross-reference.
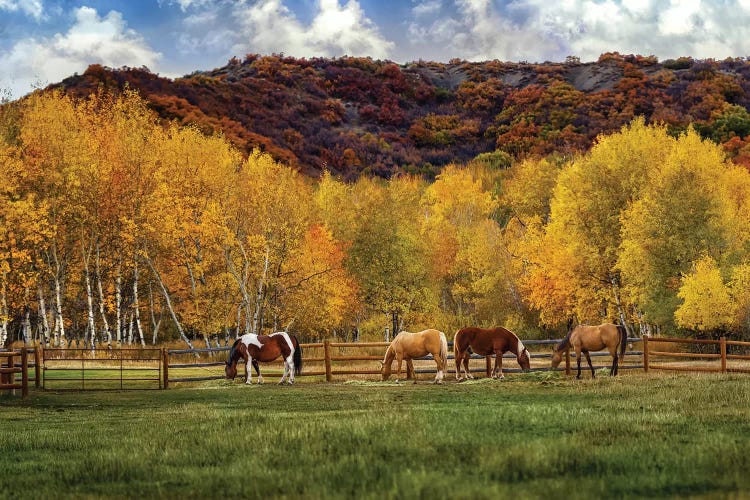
[0,373,750,499]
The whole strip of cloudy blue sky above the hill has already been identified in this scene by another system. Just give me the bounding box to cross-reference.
[0,0,750,99]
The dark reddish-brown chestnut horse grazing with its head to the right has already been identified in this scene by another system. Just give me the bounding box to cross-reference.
[453,326,531,381]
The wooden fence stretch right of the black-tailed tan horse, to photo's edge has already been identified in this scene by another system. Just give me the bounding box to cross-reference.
[643,335,750,373]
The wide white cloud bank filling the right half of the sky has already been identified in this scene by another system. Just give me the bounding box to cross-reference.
[406,0,750,61]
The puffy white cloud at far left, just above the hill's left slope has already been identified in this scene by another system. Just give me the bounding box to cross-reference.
[0,7,161,97]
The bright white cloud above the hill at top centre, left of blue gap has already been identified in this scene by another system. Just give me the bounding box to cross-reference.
[233,0,394,58]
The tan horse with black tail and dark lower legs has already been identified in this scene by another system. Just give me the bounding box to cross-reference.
[552,323,628,378]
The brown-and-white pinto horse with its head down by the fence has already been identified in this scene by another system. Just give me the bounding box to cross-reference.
[224,332,302,384]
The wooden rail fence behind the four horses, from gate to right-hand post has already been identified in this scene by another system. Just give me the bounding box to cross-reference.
[163,338,643,388]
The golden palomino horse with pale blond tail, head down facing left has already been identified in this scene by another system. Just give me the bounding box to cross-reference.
[381,329,448,384]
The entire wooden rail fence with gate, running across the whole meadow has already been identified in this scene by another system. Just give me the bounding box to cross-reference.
[0,336,750,396]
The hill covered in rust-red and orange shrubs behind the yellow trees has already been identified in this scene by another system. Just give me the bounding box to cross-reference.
[53,53,750,178]
